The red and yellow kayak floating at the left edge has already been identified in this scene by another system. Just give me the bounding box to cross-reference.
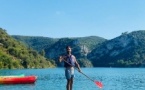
[0,76,37,84]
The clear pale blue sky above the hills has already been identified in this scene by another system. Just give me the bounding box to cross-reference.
[0,0,145,39]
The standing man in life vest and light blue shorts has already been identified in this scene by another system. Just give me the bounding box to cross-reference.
[59,46,81,90]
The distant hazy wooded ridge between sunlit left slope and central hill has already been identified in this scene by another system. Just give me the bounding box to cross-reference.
[12,35,59,52]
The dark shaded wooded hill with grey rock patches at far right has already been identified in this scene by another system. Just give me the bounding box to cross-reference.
[88,30,145,67]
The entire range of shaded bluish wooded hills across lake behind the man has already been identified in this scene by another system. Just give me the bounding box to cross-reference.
[14,30,145,67]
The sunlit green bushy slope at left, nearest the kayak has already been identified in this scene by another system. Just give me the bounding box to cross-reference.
[0,28,54,69]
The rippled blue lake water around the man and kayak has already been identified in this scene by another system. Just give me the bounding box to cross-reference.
[0,68,145,90]
